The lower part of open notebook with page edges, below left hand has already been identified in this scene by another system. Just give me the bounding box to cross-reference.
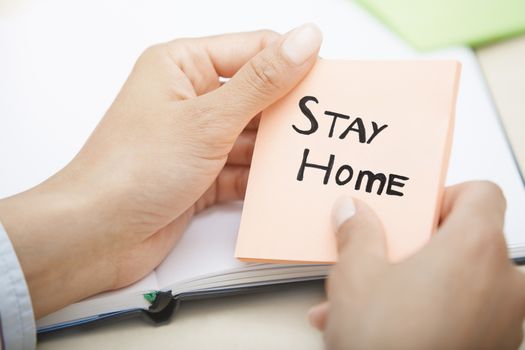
[37,202,328,333]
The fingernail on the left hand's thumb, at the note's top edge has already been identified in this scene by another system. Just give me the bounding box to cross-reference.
[281,23,323,66]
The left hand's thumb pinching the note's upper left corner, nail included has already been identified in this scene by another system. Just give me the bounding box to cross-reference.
[203,24,322,133]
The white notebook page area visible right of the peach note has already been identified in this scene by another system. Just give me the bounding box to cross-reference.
[431,49,525,252]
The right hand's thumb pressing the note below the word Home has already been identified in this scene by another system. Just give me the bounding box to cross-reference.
[332,196,387,269]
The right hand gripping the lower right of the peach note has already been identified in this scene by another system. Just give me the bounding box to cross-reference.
[310,182,525,349]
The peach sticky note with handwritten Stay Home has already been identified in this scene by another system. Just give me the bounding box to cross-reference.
[235,59,460,263]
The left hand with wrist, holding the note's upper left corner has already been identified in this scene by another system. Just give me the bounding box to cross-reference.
[0,25,321,318]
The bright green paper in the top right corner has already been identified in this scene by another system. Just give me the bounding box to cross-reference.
[357,0,525,50]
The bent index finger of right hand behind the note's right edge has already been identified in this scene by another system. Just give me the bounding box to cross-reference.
[428,181,514,278]
